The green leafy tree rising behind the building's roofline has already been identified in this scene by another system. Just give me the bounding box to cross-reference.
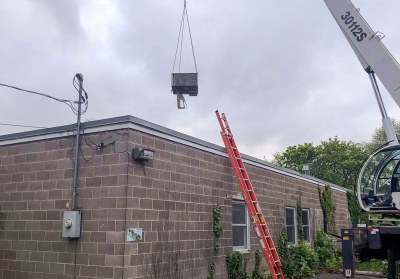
[272,137,368,189]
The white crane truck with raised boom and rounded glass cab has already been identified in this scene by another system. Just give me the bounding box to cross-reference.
[324,0,400,279]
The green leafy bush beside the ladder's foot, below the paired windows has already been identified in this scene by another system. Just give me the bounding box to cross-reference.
[277,230,318,278]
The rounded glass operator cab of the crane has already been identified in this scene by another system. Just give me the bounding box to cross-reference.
[357,143,400,213]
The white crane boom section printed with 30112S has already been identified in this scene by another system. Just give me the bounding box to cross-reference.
[324,0,400,107]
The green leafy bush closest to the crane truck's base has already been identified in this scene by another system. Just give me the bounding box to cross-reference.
[314,230,342,269]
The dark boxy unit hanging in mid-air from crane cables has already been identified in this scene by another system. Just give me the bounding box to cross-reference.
[171,73,199,96]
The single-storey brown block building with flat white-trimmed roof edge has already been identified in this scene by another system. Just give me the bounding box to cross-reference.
[0,116,350,279]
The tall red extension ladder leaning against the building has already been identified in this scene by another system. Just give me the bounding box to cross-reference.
[215,110,284,279]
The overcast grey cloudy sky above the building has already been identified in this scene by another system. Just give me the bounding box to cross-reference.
[0,0,400,159]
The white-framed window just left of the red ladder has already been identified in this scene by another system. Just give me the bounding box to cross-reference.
[232,201,249,251]
